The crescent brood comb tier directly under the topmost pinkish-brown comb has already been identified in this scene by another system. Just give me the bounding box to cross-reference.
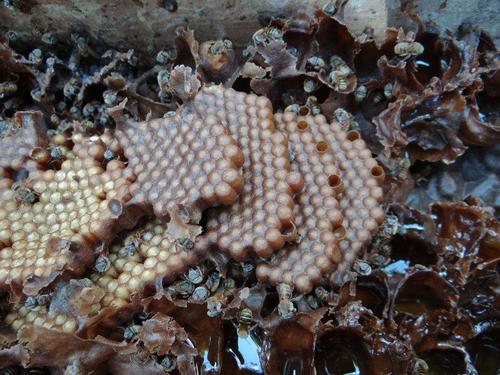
[194,86,303,260]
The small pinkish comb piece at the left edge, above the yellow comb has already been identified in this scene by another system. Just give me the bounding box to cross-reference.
[0,112,48,175]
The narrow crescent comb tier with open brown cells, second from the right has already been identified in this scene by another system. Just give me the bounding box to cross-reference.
[257,114,345,293]
